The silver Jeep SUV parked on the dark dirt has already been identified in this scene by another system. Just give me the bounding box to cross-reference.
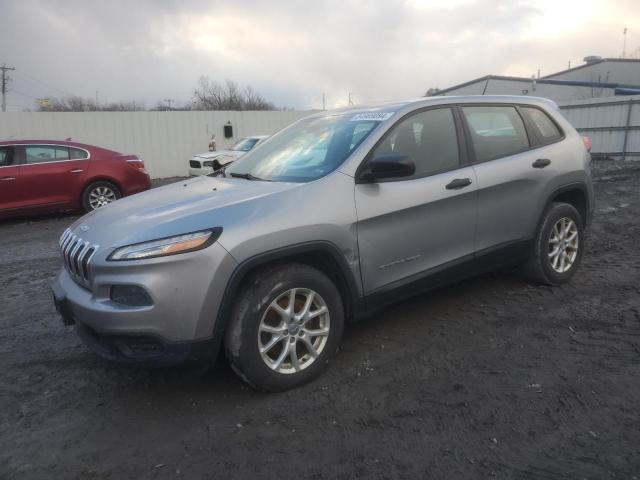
[52,96,593,391]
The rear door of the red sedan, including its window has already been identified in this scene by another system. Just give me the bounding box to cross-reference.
[20,145,89,207]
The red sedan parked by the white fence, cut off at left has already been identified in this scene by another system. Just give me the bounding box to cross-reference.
[0,140,151,218]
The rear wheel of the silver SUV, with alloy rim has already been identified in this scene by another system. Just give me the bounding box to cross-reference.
[524,202,584,285]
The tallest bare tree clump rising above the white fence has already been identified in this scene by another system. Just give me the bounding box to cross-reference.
[193,77,275,110]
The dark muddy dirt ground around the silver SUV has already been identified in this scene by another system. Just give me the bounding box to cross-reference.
[0,162,640,480]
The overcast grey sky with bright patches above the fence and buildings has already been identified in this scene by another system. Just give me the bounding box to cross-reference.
[0,0,640,110]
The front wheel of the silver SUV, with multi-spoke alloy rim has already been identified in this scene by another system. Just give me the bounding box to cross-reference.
[225,263,344,392]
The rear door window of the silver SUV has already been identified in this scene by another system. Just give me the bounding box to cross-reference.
[462,105,530,162]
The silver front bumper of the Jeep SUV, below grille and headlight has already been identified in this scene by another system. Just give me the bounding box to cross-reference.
[51,243,236,364]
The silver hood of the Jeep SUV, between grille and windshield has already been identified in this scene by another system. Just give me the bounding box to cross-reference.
[71,176,304,250]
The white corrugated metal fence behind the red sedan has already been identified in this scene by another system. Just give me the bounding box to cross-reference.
[0,110,313,178]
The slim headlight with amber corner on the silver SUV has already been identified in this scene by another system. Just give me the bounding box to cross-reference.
[108,227,222,260]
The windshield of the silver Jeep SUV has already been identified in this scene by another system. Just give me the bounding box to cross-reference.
[225,114,380,182]
